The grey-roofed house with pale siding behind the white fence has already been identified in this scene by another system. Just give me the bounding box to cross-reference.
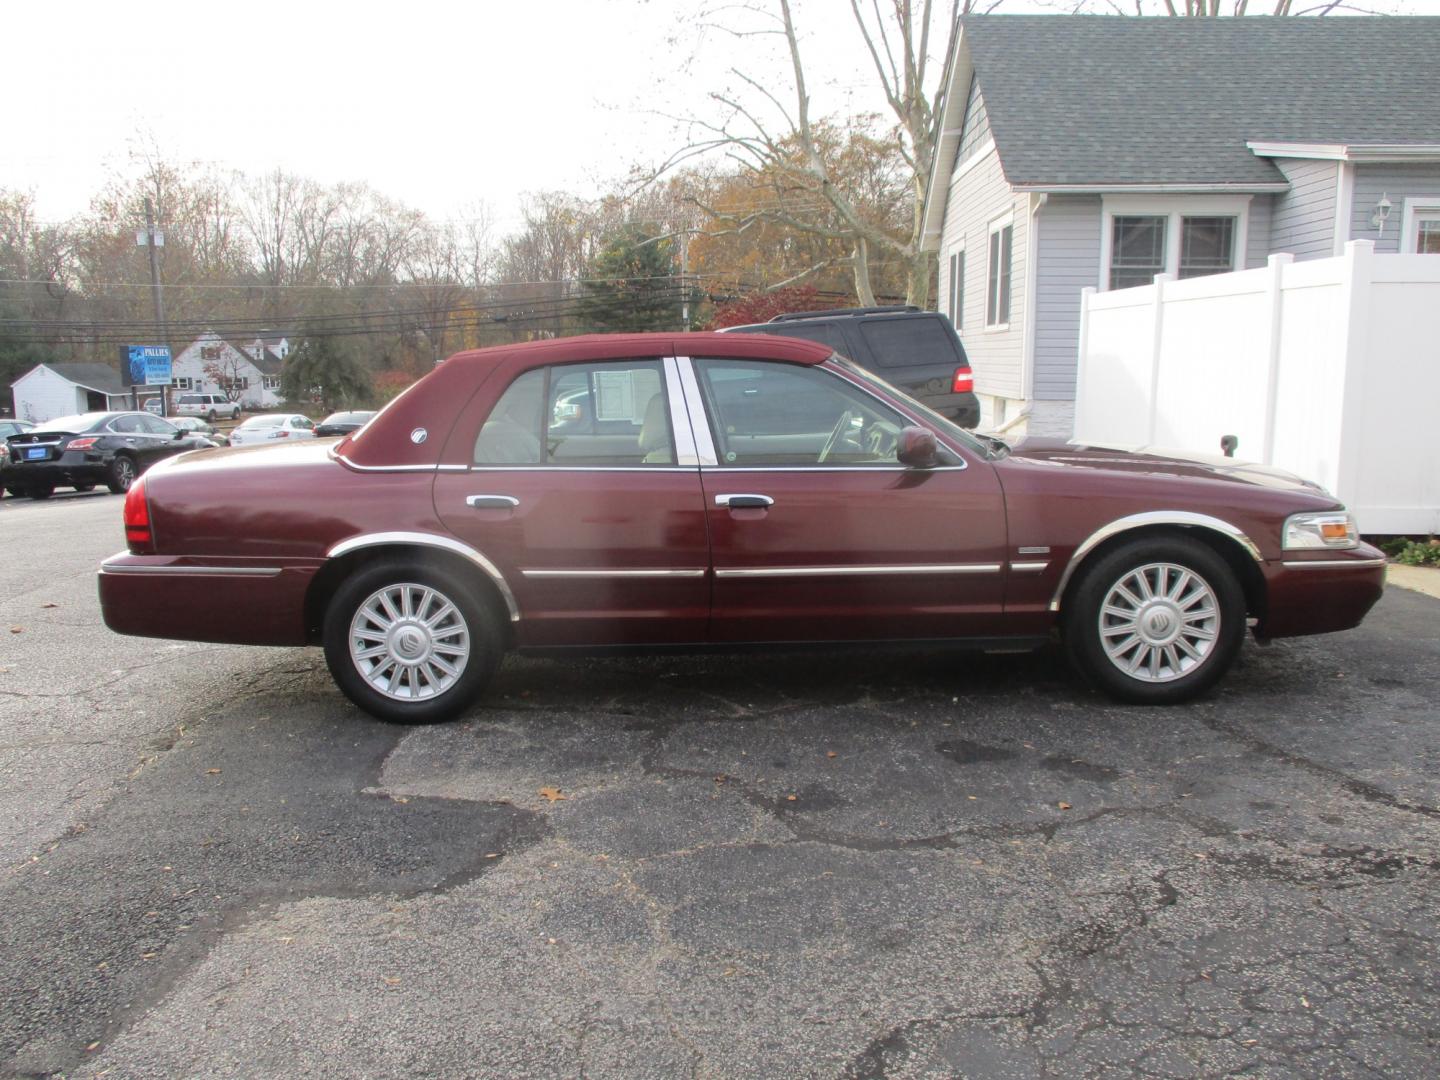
[924,16,1440,436]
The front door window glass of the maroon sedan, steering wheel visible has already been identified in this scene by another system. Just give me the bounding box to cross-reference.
[696,360,907,468]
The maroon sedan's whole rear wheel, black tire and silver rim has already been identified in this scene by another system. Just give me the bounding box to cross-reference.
[324,560,504,724]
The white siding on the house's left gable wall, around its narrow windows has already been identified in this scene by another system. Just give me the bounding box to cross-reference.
[940,144,1028,399]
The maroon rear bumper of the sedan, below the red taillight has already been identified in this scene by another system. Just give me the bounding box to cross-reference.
[99,552,321,645]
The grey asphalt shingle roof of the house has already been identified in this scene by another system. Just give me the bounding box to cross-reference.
[960,14,1440,184]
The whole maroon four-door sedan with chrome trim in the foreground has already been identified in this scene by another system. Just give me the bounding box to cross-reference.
[99,334,1384,721]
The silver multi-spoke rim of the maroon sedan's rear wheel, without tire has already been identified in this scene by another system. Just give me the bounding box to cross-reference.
[350,582,469,701]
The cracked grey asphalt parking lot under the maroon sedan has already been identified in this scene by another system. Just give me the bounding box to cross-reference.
[0,494,1440,1080]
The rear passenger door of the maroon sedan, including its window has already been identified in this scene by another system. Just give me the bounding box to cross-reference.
[435,360,710,647]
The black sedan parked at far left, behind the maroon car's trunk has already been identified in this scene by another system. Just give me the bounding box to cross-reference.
[3,412,210,498]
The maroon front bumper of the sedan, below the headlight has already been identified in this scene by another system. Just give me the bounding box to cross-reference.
[1256,544,1385,638]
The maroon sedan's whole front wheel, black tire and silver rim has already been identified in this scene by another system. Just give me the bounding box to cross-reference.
[1061,536,1246,704]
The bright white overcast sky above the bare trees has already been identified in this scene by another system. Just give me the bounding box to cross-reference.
[0,0,1440,233]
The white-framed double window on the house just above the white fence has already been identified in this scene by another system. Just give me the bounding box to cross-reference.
[1100,194,1250,289]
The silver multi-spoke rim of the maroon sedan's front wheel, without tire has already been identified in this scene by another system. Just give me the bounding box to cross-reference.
[1100,563,1220,683]
